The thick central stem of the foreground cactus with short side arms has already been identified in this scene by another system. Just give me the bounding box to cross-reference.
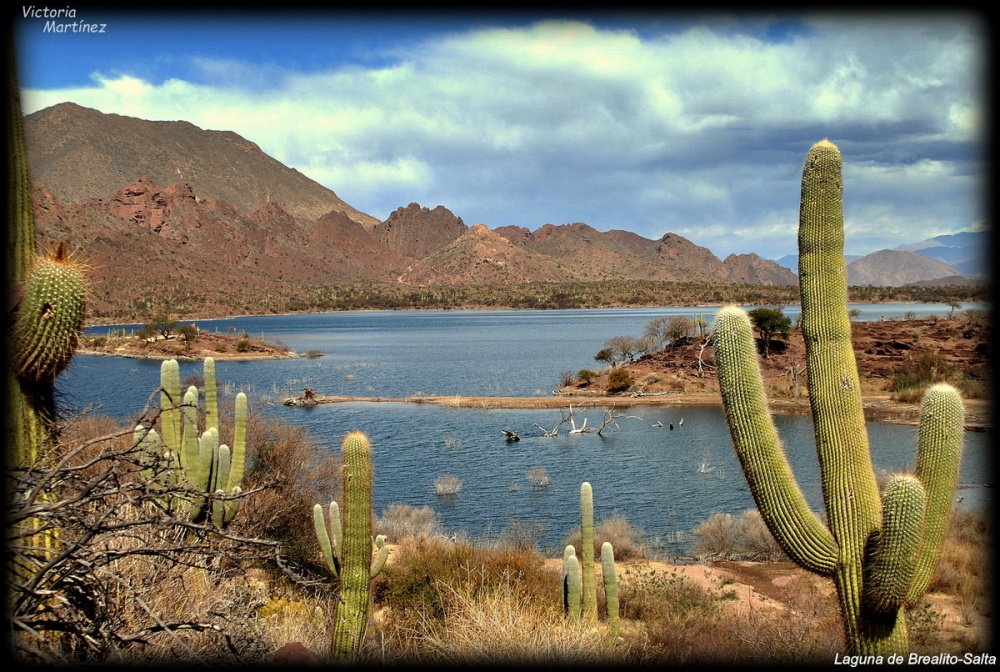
[332,431,372,661]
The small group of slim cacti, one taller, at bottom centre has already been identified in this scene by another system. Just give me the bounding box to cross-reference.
[562,481,618,638]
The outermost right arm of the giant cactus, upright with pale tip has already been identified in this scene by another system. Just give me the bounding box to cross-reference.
[907,384,965,605]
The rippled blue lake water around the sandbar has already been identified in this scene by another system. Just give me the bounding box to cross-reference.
[58,304,992,552]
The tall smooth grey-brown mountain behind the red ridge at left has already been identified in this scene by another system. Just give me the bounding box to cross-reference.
[24,103,378,225]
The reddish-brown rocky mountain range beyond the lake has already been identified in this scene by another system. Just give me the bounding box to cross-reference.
[25,103,984,313]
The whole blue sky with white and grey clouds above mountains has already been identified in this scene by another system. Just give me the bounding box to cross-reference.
[13,3,992,259]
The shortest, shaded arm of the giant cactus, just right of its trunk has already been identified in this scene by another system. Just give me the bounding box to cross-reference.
[864,475,927,615]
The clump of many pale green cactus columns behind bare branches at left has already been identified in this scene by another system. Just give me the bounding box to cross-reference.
[134,357,248,527]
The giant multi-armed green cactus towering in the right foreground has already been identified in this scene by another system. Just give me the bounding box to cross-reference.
[714,140,964,655]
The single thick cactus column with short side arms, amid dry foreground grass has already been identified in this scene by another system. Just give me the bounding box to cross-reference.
[313,431,389,661]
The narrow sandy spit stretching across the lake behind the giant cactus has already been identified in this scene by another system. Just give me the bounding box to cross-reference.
[283,392,993,432]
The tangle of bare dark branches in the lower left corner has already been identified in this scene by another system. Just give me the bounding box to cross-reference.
[5,412,292,664]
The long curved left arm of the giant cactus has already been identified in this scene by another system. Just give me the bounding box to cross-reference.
[713,306,837,575]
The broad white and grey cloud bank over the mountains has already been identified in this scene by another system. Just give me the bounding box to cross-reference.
[25,16,984,257]
